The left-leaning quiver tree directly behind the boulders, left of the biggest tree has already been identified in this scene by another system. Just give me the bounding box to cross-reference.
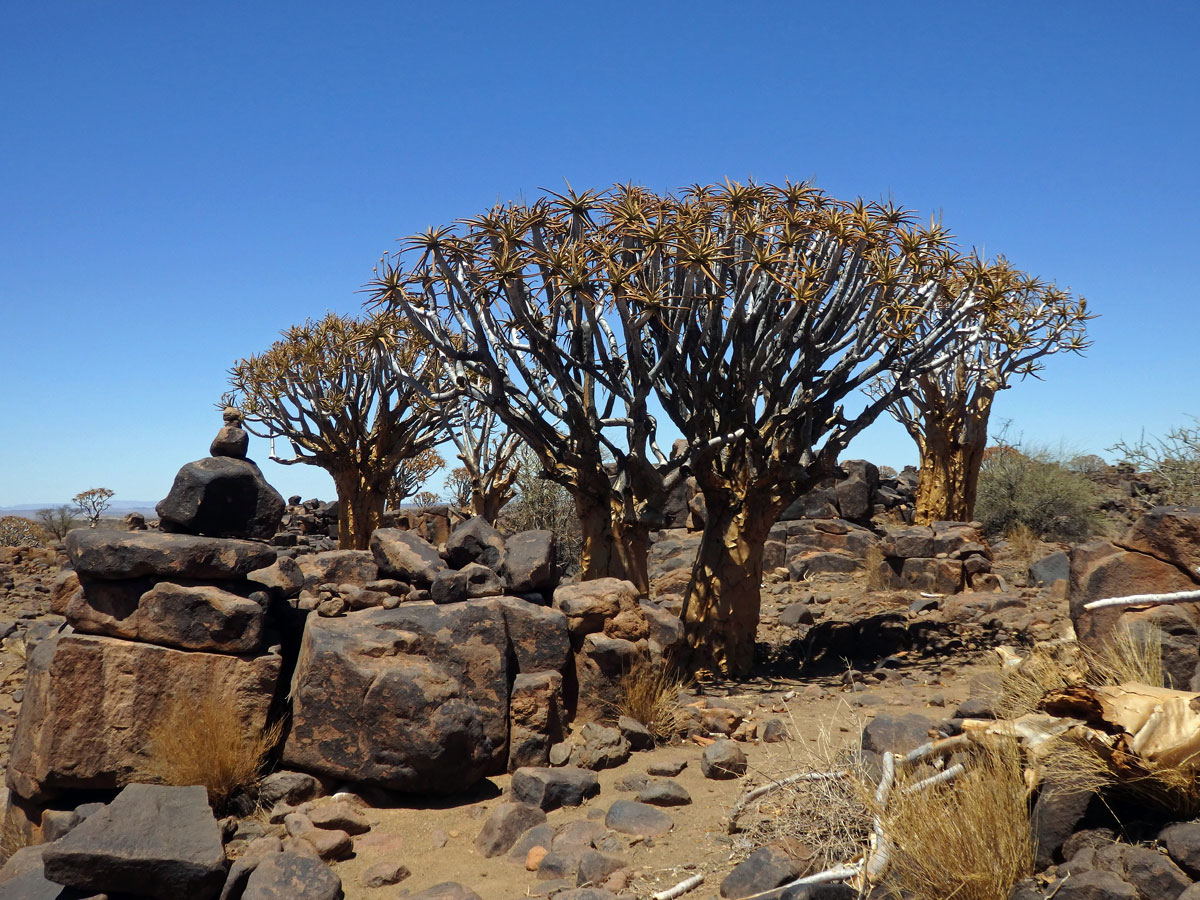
[367,190,683,590]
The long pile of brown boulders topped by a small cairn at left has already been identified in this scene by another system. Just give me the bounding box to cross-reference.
[7,420,683,859]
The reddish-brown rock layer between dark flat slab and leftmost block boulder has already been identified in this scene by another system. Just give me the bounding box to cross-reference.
[65,578,266,653]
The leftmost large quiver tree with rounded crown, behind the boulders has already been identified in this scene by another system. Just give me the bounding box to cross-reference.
[222,312,442,550]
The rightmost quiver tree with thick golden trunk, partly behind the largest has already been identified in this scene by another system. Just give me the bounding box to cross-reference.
[870,258,1093,524]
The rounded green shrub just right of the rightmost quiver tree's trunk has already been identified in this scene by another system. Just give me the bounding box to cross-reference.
[976,444,1100,541]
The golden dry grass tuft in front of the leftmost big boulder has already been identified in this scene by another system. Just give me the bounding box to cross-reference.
[146,694,283,814]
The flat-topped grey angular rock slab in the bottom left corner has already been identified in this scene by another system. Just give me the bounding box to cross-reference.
[42,785,226,900]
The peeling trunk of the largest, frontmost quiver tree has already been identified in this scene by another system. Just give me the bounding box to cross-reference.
[684,490,778,676]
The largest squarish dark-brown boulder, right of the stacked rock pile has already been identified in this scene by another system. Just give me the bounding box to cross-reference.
[283,600,509,794]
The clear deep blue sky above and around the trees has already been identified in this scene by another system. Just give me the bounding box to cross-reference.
[0,0,1200,505]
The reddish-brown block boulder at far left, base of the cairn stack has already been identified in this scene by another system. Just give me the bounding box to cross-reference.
[7,634,281,799]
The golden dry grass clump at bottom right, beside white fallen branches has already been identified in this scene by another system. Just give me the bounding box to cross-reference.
[884,742,1033,900]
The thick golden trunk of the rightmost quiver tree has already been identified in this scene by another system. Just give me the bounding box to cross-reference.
[913,400,991,524]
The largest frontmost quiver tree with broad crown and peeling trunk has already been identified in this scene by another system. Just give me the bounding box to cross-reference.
[606,184,980,673]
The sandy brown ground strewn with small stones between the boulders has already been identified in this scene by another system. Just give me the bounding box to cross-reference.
[0,535,1069,900]
